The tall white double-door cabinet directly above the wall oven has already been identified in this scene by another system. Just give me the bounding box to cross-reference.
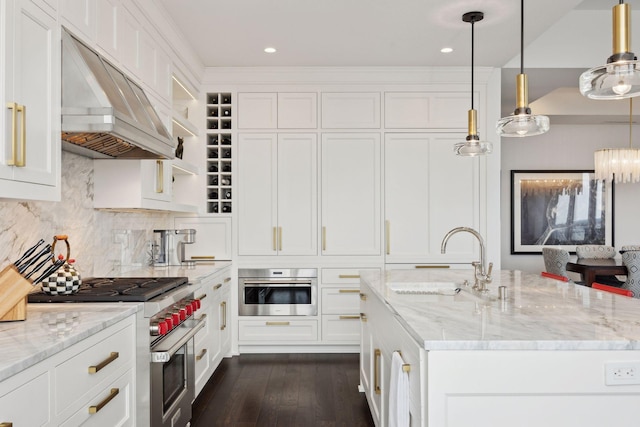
[238,134,318,255]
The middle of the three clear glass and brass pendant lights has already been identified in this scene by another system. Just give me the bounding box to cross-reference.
[496,0,549,137]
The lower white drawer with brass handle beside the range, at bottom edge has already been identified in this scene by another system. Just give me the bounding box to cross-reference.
[60,369,135,427]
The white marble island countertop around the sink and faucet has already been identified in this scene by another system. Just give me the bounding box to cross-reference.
[361,269,640,350]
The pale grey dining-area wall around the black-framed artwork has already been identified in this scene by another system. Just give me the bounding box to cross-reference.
[500,123,640,272]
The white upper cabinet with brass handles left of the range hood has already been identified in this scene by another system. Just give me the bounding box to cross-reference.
[0,0,61,200]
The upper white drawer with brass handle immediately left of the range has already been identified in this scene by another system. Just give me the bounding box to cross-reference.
[54,325,135,414]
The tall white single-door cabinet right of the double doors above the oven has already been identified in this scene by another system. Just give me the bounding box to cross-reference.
[321,133,381,255]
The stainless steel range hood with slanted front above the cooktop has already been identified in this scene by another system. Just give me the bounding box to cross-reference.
[61,29,175,159]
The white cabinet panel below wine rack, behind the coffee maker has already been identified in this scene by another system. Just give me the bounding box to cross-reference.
[174,217,233,261]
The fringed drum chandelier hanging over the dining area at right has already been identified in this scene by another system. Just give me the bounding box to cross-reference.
[593,98,640,183]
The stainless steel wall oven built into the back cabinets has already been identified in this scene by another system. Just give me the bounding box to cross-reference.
[238,268,318,316]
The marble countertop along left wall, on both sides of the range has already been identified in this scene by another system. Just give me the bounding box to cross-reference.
[0,261,231,381]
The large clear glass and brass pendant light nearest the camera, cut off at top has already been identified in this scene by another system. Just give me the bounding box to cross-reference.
[580,0,640,99]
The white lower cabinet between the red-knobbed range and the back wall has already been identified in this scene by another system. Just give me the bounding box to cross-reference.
[195,268,231,396]
